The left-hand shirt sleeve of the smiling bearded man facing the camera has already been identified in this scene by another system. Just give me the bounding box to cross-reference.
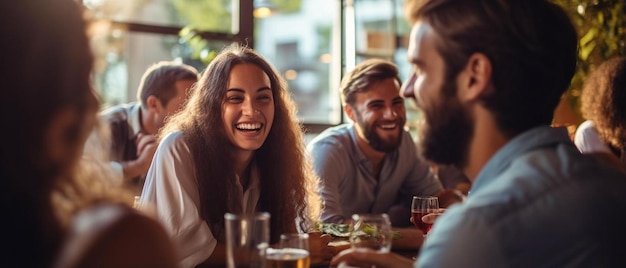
[307,138,355,223]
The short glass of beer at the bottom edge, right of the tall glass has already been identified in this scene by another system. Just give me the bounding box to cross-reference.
[265,233,311,268]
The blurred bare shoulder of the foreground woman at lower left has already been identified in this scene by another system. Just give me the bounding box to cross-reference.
[56,204,176,267]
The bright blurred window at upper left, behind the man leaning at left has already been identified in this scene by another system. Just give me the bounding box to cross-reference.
[83,0,252,109]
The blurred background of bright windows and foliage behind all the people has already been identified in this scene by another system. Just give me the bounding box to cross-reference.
[82,0,626,140]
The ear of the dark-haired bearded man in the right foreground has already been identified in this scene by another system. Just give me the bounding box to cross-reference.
[457,53,492,101]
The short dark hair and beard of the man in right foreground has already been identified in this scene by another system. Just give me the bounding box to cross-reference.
[405,0,578,135]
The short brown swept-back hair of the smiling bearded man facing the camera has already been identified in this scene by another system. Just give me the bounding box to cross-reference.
[340,58,402,105]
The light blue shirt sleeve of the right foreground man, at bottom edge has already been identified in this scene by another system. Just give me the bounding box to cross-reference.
[416,204,510,268]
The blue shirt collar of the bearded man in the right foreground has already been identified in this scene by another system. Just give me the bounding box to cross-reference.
[471,126,571,193]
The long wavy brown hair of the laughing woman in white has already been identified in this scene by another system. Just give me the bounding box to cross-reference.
[159,44,321,242]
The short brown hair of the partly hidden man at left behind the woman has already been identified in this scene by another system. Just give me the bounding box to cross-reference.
[137,61,198,106]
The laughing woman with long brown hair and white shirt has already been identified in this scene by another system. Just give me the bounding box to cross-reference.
[140,44,334,267]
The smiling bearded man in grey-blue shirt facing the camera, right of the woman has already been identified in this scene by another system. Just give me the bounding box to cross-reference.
[307,59,464,248]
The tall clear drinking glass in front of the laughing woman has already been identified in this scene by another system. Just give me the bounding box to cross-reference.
[224,212,270,268]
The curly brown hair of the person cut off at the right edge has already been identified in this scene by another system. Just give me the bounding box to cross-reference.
[581,57,626,151]
